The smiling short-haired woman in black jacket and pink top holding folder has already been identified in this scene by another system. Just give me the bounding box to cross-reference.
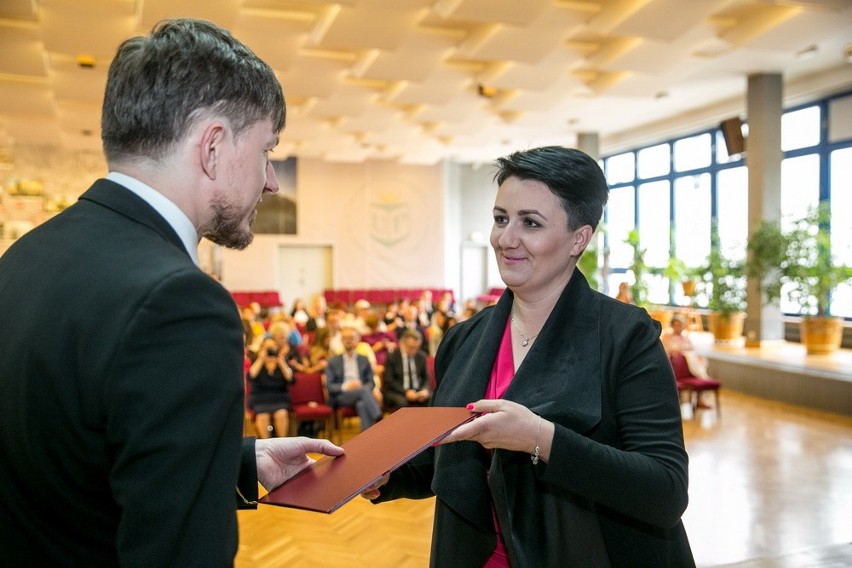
[364,146,695,568]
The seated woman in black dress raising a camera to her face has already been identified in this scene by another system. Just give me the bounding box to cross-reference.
[248,336,293,438]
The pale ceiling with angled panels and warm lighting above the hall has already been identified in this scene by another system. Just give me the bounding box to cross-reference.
[0,0,852,164]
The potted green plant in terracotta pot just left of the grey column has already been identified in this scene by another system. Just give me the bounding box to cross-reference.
[700,239,746,343]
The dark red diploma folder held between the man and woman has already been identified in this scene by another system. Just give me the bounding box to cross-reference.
[259,406,476,513]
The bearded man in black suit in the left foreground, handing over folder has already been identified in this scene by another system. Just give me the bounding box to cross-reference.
[0,20,342,566]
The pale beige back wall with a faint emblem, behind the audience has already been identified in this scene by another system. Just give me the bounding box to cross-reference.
[221,159,455,299]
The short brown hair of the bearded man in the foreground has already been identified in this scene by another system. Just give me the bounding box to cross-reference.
[101,19,286,162]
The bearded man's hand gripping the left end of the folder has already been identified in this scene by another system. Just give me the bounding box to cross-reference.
[254,437,343,490]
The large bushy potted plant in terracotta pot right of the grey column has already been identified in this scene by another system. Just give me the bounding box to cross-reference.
[746,202,852,353]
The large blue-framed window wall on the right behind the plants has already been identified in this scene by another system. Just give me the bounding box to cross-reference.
[603,93,852,318]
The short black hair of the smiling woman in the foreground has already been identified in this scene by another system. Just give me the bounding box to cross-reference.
[494,146,609,231]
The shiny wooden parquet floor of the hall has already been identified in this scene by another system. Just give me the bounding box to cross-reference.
[235,387,852,568]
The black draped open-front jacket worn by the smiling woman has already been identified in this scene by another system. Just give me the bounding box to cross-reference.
[379,271,694,568]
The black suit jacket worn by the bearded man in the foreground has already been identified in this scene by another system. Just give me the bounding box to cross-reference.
[0,180,257,566]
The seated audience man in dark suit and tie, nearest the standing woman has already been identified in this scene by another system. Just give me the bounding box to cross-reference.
[382,329,432,412]
